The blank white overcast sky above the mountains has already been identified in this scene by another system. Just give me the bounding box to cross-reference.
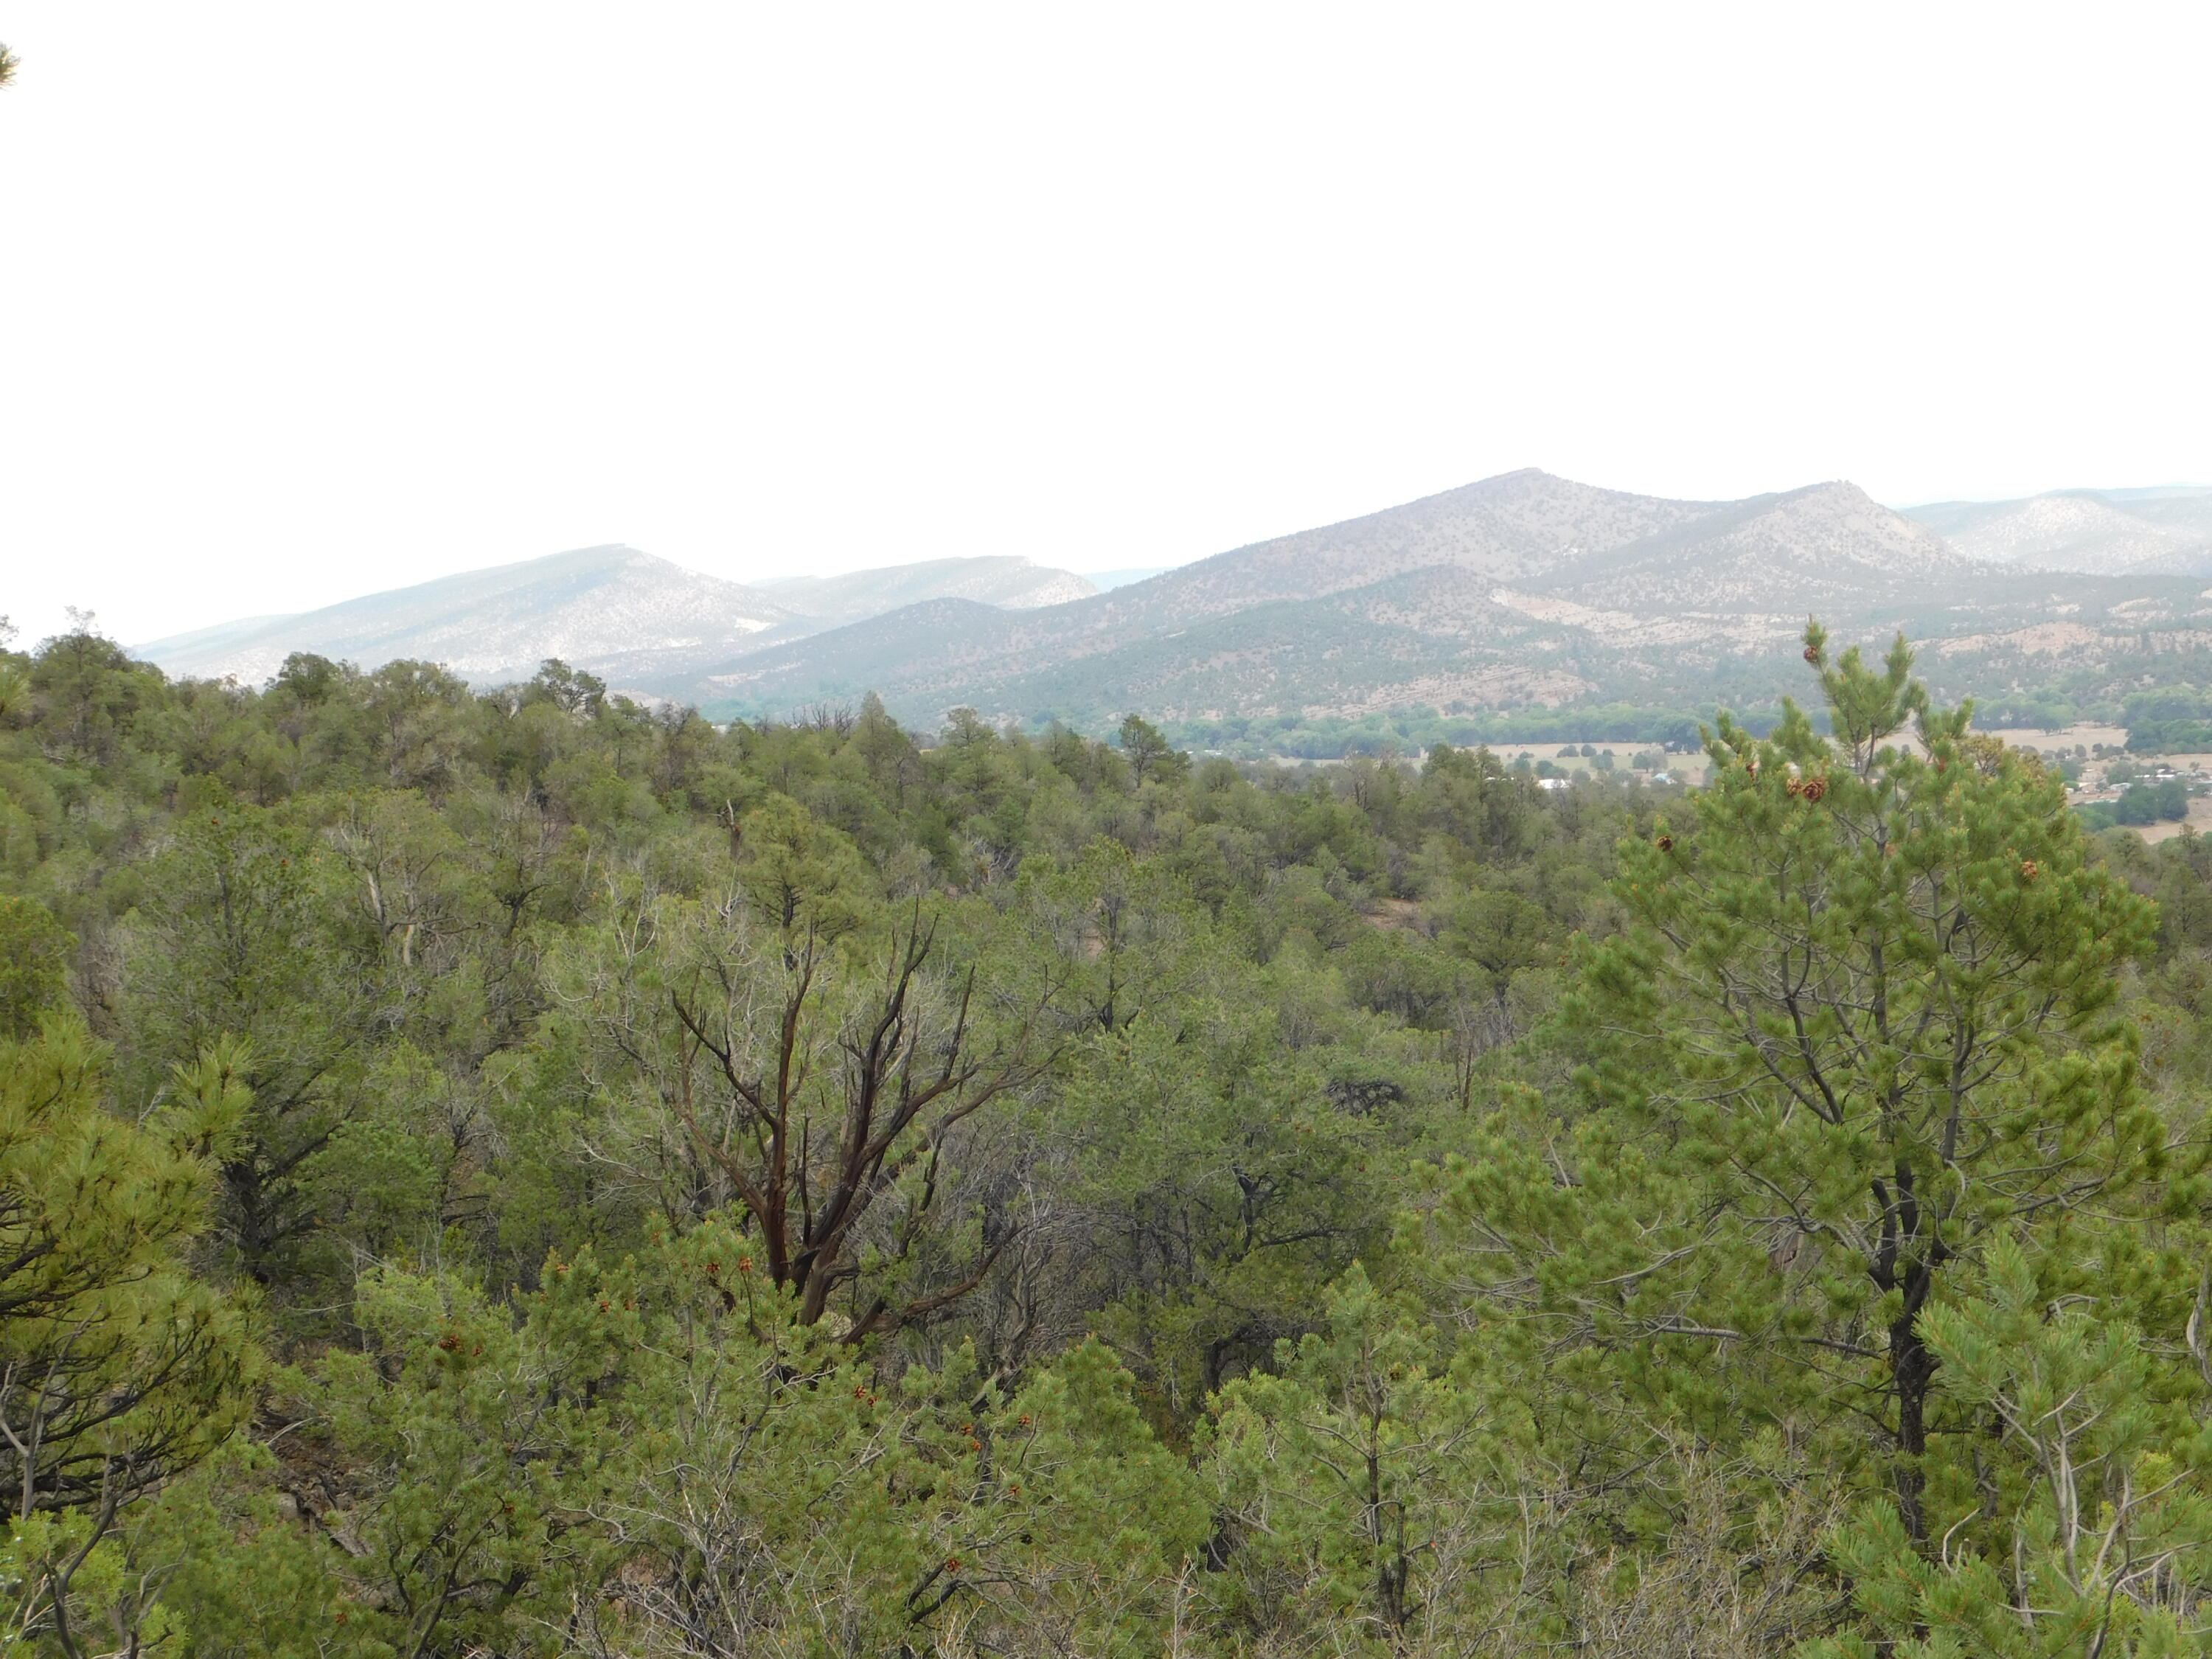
[0,0,2212,639]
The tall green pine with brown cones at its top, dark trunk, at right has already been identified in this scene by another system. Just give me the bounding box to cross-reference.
[1553,626,2174,1540]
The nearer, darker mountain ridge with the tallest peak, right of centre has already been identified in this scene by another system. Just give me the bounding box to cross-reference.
[681,471,2212,726]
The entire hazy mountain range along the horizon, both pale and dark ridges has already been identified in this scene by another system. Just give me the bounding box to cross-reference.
[139,469,2212,728]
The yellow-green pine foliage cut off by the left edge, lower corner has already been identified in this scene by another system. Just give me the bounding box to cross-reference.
[0,1018,259,1652]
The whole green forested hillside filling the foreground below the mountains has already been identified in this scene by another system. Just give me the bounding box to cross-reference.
[0,630,2212,1659]
